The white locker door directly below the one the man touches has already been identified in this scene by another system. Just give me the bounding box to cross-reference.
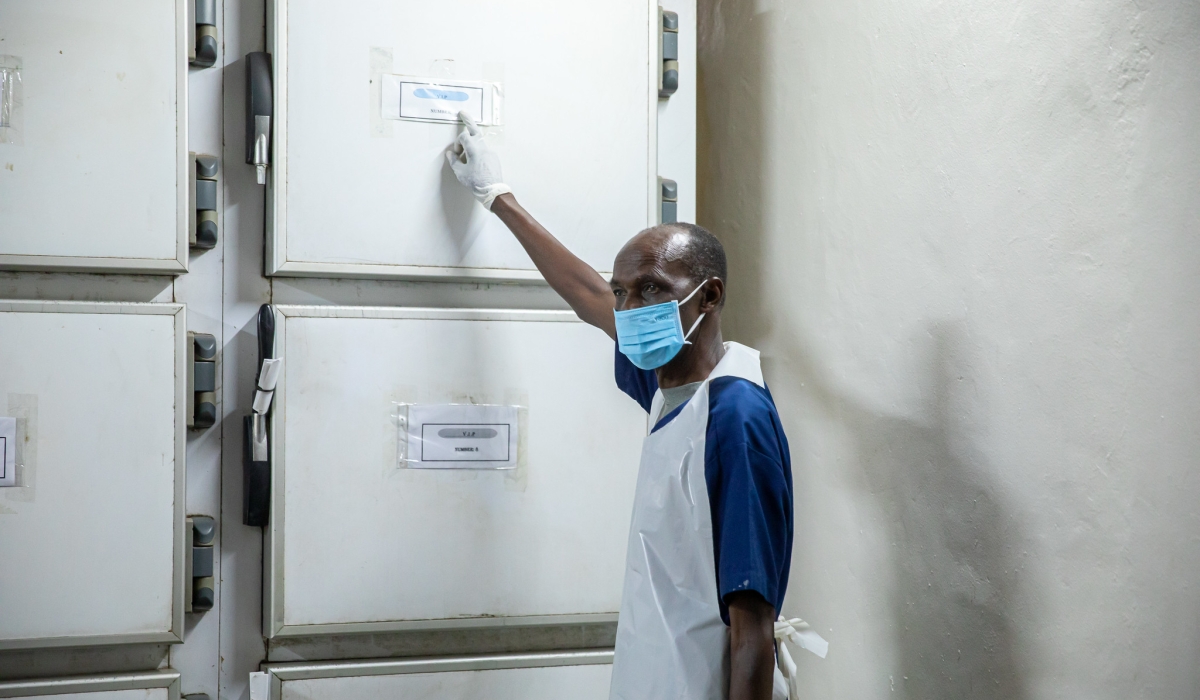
[264,306,646,638]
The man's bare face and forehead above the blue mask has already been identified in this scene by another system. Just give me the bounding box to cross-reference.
[611,228,695,311]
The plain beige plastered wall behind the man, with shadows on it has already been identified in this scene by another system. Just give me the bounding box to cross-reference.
[698,0,1200,700]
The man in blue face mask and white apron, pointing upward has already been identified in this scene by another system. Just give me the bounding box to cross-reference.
[446,114,792,700]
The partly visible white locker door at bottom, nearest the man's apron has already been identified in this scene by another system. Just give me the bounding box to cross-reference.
[266,651,612,700]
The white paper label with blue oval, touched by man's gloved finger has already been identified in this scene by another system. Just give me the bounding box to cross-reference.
[379,76,502,126]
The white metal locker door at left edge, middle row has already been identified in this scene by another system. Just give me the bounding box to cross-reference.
[0,301,187,650]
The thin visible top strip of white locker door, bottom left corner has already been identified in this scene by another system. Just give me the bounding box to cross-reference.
[0,670,179,700]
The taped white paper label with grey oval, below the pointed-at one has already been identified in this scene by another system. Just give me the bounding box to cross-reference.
[401,403,518,469]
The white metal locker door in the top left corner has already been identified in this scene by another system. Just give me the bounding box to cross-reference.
[0,0,190,273]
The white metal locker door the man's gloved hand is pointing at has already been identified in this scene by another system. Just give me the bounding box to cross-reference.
[268,0,658,279]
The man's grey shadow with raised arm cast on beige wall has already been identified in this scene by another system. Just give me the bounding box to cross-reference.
[796,324,1028,700]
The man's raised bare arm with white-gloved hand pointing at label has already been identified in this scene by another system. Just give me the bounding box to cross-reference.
[446,114,617,339]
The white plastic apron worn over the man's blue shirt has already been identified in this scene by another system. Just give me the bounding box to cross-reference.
[608,342,763,700]
